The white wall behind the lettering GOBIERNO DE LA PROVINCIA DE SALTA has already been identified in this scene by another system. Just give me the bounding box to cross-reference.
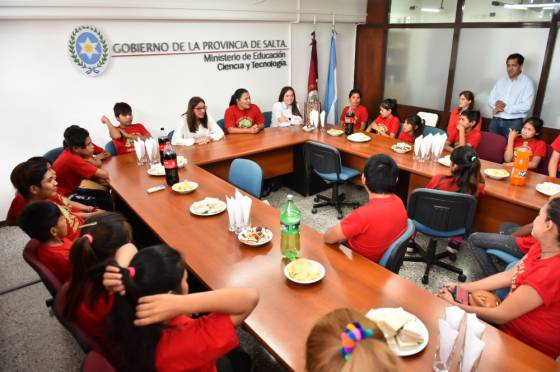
[0,0,367,220]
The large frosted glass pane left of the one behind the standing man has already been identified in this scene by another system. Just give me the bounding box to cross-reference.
[384,28,453,110]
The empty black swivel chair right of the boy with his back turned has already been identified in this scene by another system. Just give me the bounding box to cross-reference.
[404,188,477,284]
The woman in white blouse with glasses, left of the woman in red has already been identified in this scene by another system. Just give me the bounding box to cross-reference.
[171,97,224,146]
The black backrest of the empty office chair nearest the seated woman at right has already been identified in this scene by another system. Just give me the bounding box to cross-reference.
[407,188,477,236]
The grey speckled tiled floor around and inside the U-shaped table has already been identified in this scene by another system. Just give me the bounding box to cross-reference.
[0,185,481,372]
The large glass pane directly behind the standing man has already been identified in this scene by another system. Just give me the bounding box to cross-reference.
[451,28,548,118]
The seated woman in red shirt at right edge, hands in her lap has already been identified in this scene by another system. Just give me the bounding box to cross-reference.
[438,199,560,358]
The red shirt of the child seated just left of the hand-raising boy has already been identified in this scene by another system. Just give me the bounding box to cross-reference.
[53,149,97,196]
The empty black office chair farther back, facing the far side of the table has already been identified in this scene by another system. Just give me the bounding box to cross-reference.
[305,141,361,220]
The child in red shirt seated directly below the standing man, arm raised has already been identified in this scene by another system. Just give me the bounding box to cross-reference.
[504,117,547,169]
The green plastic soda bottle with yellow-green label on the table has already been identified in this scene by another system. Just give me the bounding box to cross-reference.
[280,195,301,261]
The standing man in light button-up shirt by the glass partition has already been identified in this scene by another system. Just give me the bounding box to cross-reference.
[488,53,535,138]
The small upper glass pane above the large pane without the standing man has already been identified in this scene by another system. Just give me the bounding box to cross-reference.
[389,0,457,23]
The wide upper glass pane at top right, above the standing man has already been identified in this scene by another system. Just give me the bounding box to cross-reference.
[463,0,553,22]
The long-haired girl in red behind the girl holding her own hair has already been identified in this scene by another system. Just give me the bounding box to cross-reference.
[64,212,137,338]
